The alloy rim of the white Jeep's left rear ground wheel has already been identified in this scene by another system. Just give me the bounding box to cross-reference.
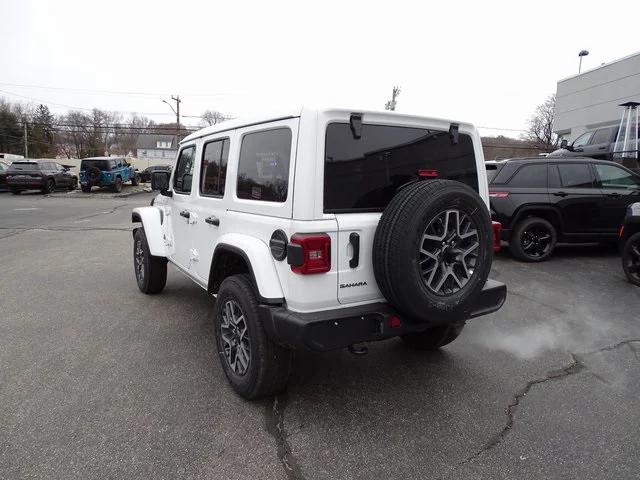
[220,300,251,376]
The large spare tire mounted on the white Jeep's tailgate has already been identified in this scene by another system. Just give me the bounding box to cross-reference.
[373,180,493,324]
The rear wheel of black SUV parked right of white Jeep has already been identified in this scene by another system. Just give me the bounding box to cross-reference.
[509,217,558,262]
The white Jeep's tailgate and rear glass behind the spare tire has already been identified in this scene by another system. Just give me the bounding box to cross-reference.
[324,122,478,304]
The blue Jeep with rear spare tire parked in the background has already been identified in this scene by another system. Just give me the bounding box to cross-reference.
[80,157,140,192]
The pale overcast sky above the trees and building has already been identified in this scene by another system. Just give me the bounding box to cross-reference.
[0,0,640,136]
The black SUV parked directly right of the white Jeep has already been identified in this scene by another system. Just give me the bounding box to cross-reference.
[486,157,640,262]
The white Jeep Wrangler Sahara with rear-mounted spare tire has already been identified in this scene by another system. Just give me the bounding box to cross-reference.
[132,108,506,399]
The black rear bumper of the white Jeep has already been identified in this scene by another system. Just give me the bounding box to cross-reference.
[260,280,507,352]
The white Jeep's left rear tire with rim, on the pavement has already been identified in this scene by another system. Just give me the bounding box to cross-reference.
[214,275,291,400]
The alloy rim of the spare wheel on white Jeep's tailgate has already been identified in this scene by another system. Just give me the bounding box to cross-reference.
[419,209,480,295]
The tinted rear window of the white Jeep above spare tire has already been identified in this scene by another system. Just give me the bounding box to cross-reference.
[324,123,478,212]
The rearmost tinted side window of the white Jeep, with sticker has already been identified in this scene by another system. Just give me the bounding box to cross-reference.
[237,128,291,202]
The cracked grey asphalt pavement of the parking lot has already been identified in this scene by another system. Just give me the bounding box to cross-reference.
[0,194,640,480]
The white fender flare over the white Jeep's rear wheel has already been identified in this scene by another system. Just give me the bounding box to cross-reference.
[208,233,284,305]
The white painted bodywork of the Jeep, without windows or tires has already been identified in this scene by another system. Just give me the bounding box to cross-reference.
[136,108,489,312]
